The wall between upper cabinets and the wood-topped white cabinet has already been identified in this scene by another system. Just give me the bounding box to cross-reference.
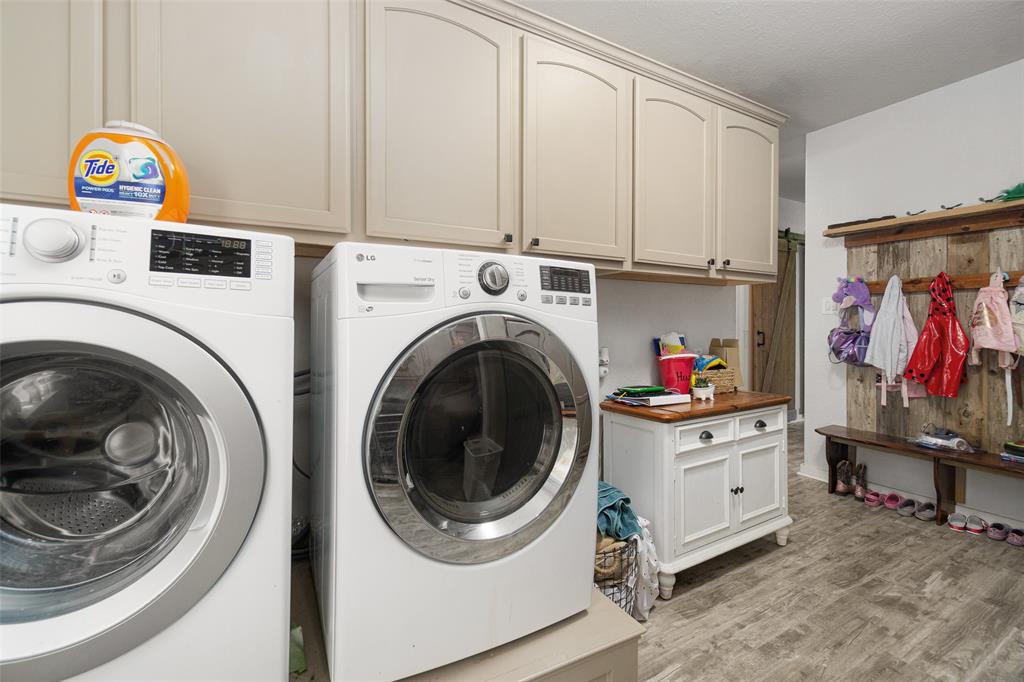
[597,279,736,393]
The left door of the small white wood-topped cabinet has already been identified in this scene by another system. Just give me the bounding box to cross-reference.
[675,445,734,555]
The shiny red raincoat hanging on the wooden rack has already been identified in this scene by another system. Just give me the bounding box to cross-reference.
[903,272,968,397]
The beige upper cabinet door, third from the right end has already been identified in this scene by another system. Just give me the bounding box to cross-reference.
[522,36,633,260]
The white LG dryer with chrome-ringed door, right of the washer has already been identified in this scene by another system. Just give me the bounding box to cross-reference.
[310,243,598,680]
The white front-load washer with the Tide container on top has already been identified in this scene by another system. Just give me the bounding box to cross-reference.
[0,205,294,682]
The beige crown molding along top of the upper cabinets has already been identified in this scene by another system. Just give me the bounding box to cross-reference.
[449,0,790,126]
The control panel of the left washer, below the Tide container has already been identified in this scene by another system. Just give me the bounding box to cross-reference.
[0,204,294,314]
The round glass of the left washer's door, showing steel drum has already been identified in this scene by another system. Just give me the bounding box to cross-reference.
[0,352,207,623]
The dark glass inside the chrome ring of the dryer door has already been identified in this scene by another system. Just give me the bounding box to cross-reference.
[401,343,562,523]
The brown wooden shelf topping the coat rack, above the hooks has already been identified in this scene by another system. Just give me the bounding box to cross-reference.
[822,199,1024,246]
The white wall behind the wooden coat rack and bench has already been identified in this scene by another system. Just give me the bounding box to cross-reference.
[802,60,1024,519]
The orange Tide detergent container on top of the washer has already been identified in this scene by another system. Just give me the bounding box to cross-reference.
[68,121,188,222]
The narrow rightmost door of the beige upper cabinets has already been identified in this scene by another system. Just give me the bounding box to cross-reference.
[718,108,778,274]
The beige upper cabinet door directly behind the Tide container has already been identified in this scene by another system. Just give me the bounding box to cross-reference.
[132,0,351,232]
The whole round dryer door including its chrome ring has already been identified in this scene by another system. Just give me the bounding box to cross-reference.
[366,314,592,563]
